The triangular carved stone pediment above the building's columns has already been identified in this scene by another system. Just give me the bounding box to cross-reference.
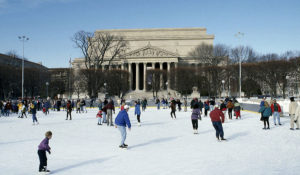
[122,44,179,58]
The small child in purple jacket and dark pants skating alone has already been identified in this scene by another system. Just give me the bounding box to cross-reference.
[38,131,52,172]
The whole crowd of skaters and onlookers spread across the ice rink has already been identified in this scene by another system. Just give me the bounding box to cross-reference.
[0,97,300,172]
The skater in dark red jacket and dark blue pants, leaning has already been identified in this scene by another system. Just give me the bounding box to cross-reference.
[209,105,226,140]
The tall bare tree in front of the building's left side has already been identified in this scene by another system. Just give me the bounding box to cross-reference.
[72,31,128,97]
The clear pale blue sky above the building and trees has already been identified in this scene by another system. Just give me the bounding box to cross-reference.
[0,0,300,67]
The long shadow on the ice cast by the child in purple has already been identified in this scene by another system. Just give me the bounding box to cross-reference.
[51,156,115,174]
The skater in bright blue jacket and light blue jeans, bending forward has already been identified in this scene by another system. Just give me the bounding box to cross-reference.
[115,105,131,148]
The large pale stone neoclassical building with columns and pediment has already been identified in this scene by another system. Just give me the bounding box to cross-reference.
[72,28,214,91]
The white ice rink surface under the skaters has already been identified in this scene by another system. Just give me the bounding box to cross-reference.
[0,108,300,175]
